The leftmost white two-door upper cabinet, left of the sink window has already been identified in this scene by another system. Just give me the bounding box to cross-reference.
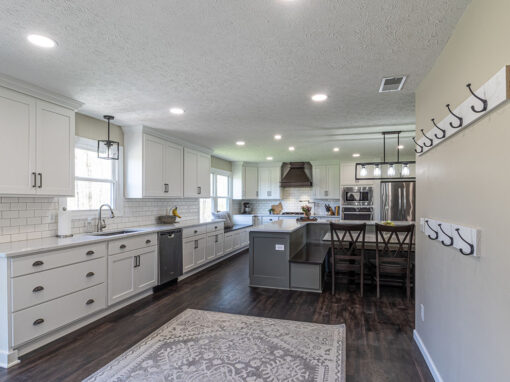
[0,87,75,196]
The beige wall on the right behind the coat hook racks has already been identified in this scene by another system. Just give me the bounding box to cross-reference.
[416,0,510,381]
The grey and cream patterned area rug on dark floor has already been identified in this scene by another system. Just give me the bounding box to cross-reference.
[85,309,345,382]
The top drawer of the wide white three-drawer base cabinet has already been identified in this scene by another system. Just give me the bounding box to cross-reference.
[11,243,106,277]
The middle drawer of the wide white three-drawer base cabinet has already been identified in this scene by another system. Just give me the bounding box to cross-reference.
[11,257,106,312]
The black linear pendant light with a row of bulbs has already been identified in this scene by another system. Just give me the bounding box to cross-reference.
[354,131,416,180]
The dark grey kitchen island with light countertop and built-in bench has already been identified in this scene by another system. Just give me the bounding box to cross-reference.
[249,217,411,292]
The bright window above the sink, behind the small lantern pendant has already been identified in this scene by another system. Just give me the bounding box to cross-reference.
[67,138,121,211]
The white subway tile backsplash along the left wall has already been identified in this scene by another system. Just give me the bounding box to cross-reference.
[0,197,199,243]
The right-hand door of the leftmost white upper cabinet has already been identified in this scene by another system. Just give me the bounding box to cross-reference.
[35,101,74,196]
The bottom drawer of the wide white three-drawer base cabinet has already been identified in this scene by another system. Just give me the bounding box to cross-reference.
[12,283,106,346]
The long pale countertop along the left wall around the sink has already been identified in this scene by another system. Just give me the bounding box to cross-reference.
[0,219,225,258]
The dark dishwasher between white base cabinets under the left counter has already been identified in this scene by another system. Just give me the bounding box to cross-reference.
[158,229,182,285]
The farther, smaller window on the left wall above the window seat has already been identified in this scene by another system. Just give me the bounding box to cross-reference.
[200,169,232,219]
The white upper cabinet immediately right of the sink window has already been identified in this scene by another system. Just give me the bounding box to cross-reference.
[124,127,183,198]
